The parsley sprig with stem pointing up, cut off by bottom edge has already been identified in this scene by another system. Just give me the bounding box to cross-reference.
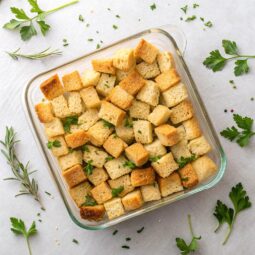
[175,215,201,255]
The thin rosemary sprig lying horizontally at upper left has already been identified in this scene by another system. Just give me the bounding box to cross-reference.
[6,48,62,60]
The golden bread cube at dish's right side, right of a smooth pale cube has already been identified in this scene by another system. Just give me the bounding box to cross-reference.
[170,100,193,124]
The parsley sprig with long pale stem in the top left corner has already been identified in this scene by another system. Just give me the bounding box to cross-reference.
[3,0,79,41]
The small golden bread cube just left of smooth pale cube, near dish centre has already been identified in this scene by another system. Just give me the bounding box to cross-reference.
[129,100,150,120]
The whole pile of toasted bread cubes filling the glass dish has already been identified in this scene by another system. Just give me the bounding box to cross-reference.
[35,39,217,221]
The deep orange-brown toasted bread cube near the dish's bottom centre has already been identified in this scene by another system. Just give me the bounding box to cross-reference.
[131,167,155,187]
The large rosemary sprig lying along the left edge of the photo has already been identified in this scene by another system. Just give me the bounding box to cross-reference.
[0,127,44,209]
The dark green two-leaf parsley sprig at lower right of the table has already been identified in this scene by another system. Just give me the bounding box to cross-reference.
[213,183,251,245]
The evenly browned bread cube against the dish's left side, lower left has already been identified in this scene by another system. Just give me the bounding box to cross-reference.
[63,164,87,188]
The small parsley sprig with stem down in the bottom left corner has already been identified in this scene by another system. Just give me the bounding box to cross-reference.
[10,217,37,255]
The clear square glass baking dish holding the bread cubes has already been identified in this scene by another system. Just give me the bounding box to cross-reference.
[23,25,226,230]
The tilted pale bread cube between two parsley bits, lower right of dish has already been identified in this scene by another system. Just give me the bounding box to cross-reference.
[151,152,179,178]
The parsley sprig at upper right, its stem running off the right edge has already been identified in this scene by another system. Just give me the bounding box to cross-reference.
[203,40,255,76]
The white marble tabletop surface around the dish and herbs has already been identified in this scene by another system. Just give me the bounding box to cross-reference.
[0,0,255,255]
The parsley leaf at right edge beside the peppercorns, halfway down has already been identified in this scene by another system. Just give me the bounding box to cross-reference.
[220,114,255,147]
